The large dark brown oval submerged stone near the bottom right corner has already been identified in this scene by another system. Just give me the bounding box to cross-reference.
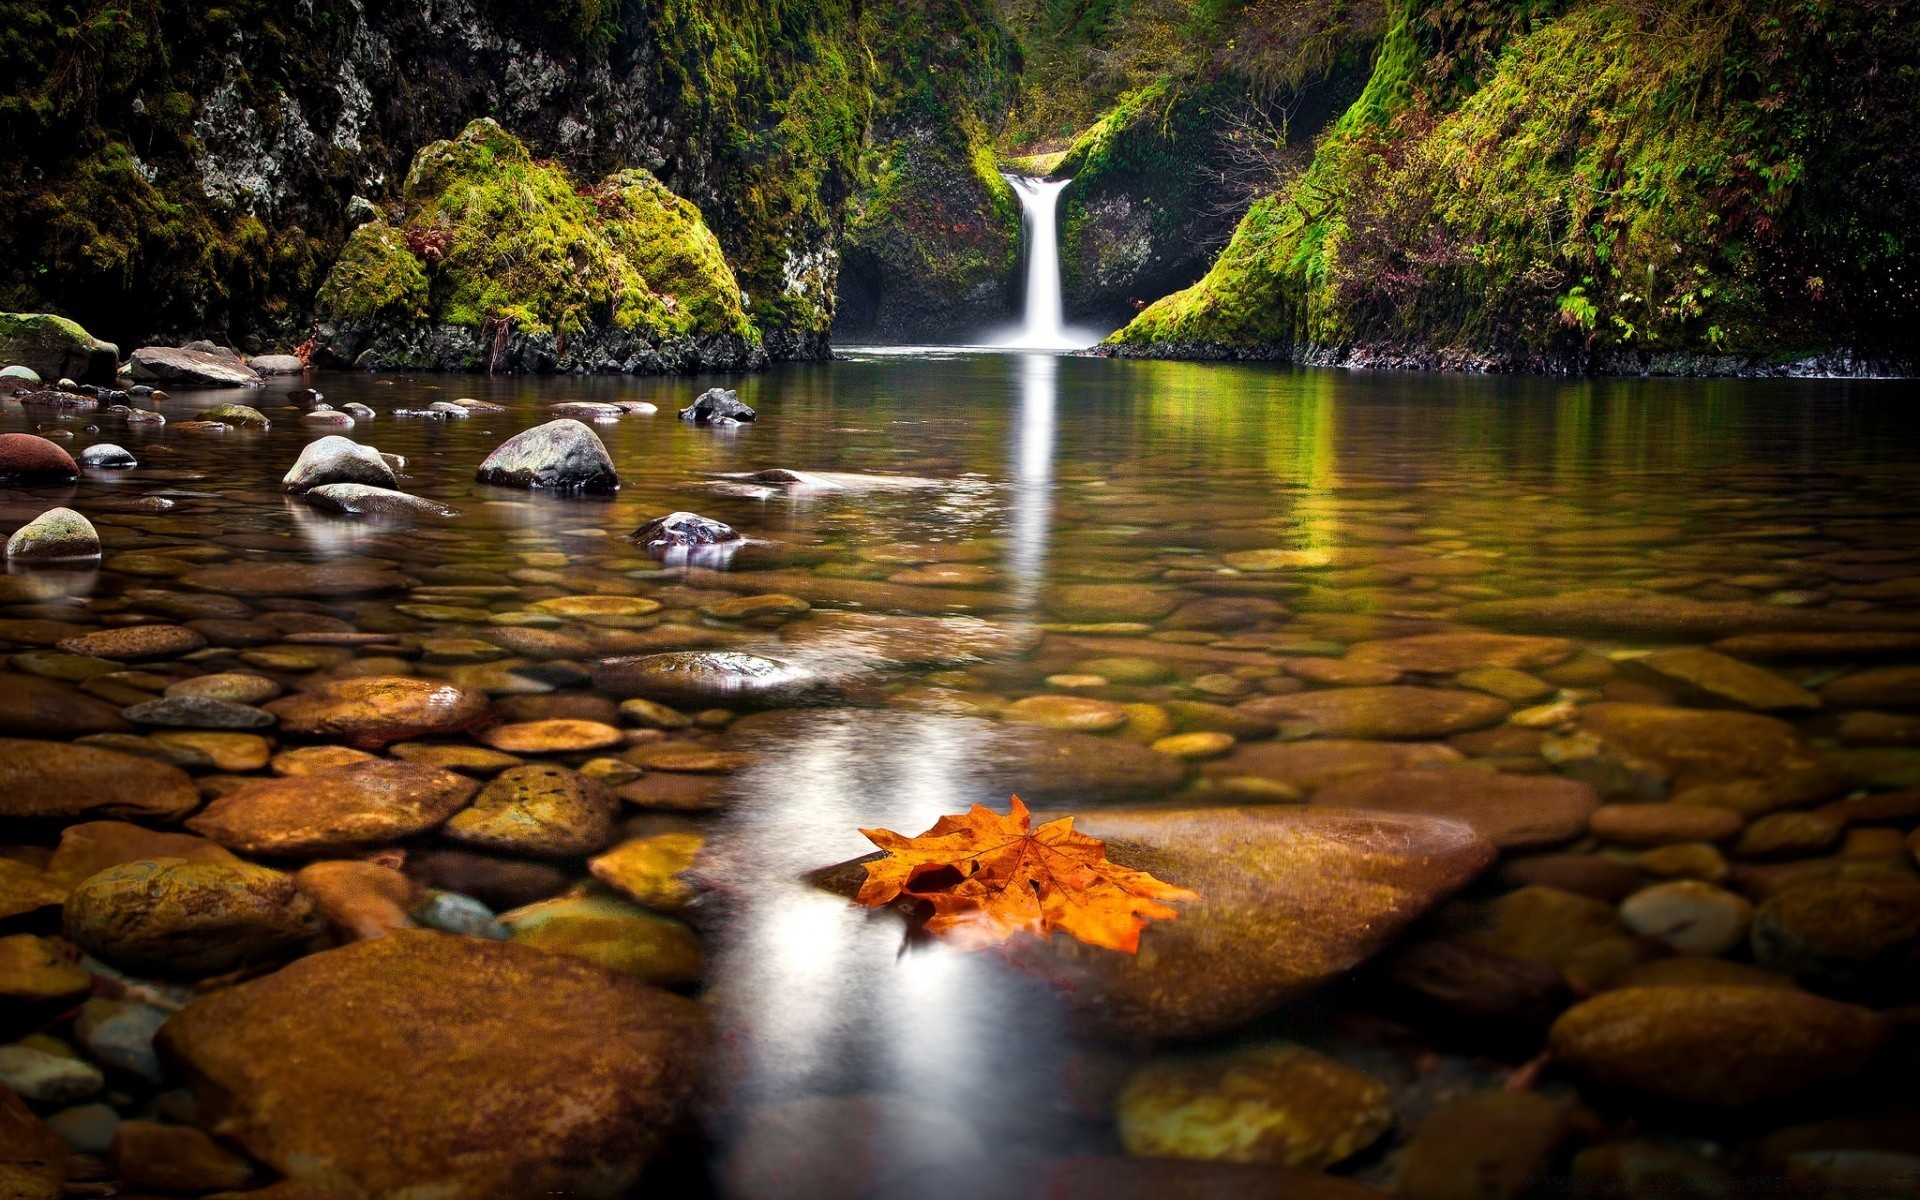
[1548,987,1887,1108]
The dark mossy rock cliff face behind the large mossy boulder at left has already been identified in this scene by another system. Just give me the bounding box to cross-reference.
[0,0,868,357]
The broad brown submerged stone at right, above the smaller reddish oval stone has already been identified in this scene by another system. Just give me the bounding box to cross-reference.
[1580,701,1845,814]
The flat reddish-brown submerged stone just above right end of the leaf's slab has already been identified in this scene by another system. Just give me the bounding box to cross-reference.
[1313,770,1599,849]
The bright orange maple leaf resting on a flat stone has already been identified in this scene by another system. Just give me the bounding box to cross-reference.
[858,797,1200,954]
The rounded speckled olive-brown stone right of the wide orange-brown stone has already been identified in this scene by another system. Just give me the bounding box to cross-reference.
[444,764,618,858]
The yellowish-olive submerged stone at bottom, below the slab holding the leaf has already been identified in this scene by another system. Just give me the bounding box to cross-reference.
[1117,1043,1394,1167]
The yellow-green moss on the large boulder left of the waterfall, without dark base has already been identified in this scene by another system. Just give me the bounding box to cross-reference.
[321,119,755,338]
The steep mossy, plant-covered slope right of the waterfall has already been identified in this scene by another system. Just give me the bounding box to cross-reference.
[1116,0,1920,365]
